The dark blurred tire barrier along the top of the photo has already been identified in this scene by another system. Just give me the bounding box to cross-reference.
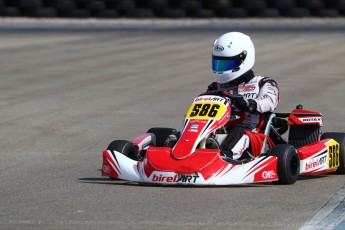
[0,0,345,18]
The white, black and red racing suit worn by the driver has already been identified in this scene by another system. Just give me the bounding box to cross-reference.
[208,71,279,160]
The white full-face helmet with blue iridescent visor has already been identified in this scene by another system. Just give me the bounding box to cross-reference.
[212,32,255,84]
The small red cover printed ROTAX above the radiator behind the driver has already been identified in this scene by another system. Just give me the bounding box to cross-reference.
[288,109,323,126]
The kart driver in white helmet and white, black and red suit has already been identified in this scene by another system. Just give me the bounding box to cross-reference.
[206,32,279,160]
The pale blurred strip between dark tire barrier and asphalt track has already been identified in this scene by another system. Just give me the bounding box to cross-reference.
[0,18,345,30]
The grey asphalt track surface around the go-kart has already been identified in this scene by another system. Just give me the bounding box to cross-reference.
[0,19,345,229]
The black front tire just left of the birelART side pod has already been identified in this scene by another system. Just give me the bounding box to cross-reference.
[271,144,300,184]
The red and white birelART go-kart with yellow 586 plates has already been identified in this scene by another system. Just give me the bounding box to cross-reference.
[102,91,345,185]
